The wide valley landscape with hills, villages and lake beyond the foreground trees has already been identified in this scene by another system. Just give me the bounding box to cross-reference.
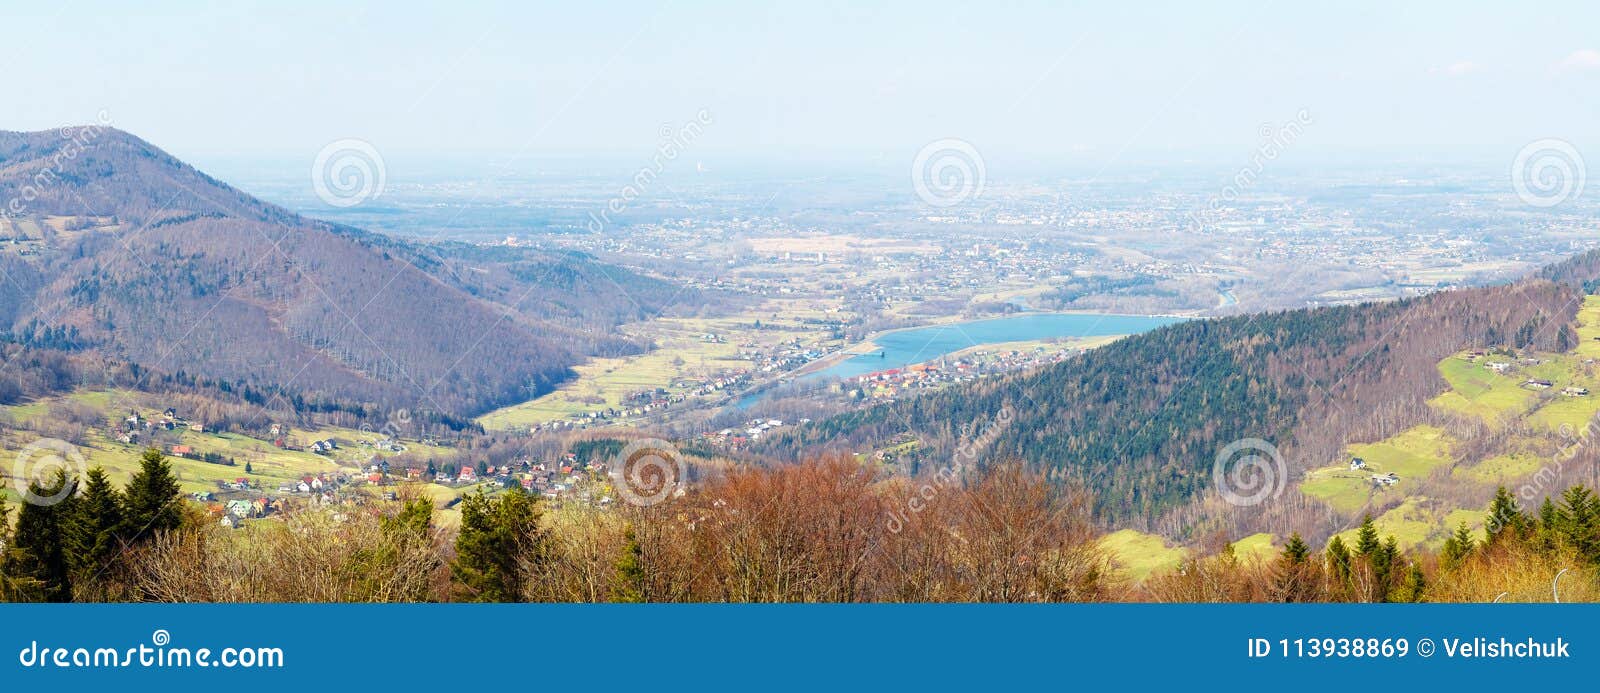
[0,125,1600,598]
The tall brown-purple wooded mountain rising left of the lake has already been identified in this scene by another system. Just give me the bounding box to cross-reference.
[0,126,702,416]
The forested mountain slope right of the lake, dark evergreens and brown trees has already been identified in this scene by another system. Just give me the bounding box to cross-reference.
[765,253,1600,538]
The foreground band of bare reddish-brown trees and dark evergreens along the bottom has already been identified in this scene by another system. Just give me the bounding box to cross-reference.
[0,451,1600,602]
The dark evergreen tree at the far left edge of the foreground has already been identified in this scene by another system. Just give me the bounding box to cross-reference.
[0,472,74,602]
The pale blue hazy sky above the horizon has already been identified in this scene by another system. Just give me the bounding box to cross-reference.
[0,0,1600,163]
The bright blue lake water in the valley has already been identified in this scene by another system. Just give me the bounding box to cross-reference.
[805,312,1184,379]
